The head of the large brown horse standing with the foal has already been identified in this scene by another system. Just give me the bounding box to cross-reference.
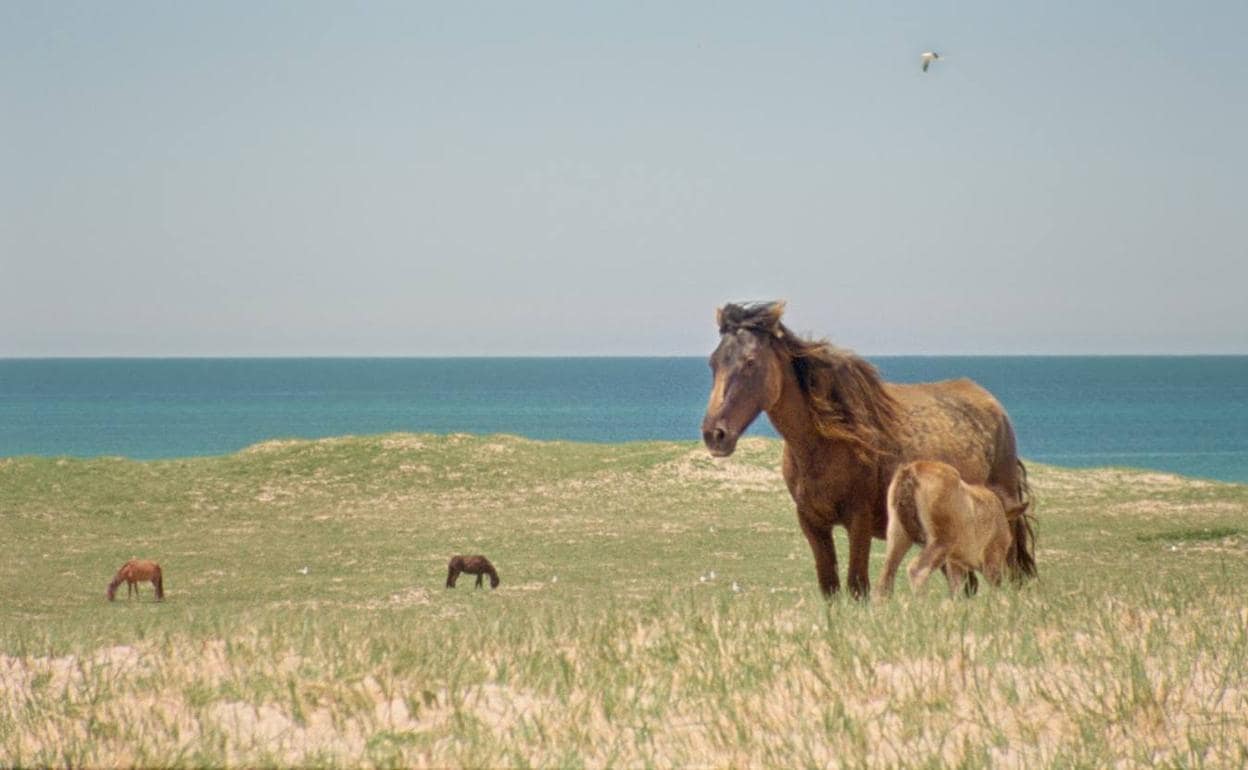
[703,302,785,457]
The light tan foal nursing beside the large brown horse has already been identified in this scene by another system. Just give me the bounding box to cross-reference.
[876,461,1027,597]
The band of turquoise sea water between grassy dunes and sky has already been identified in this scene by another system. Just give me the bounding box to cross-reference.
[0,356,1248,482]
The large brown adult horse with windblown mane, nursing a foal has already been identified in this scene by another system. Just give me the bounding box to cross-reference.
[703,302,1036,598]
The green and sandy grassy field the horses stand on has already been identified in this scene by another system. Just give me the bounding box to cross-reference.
[0,436,1248,768]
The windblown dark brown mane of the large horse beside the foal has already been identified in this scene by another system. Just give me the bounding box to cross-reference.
[718,302,899,461]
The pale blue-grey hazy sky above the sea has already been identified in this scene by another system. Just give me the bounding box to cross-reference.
[0,0,1248,357]
